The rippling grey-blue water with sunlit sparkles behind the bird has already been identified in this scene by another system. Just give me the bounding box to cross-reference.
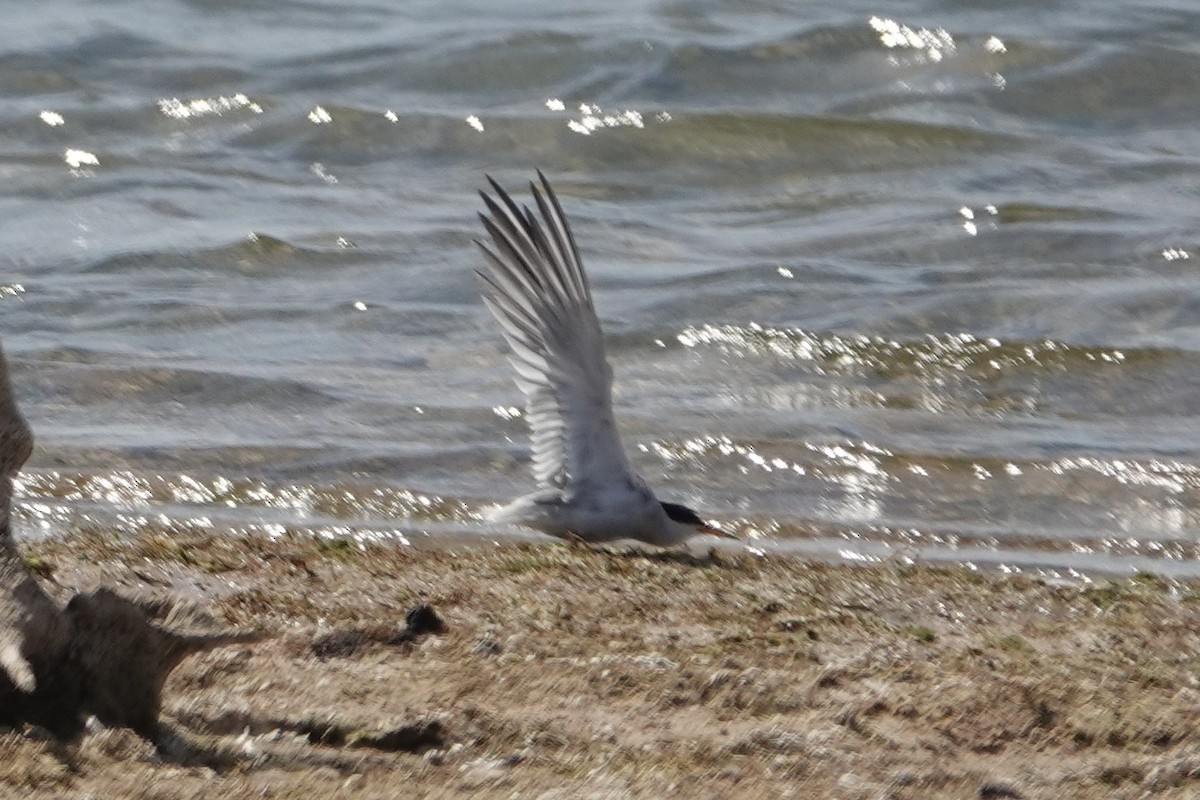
[0,0,1200,576]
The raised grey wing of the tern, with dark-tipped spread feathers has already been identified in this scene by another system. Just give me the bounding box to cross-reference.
[476,172,632,493]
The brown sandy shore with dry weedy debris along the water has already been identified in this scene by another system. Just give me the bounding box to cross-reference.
[0,535,1200,800]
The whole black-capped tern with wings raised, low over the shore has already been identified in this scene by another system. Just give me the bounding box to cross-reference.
[475,170,737,547]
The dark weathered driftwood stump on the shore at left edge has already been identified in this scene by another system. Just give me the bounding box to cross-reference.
[0,340,262,742]
